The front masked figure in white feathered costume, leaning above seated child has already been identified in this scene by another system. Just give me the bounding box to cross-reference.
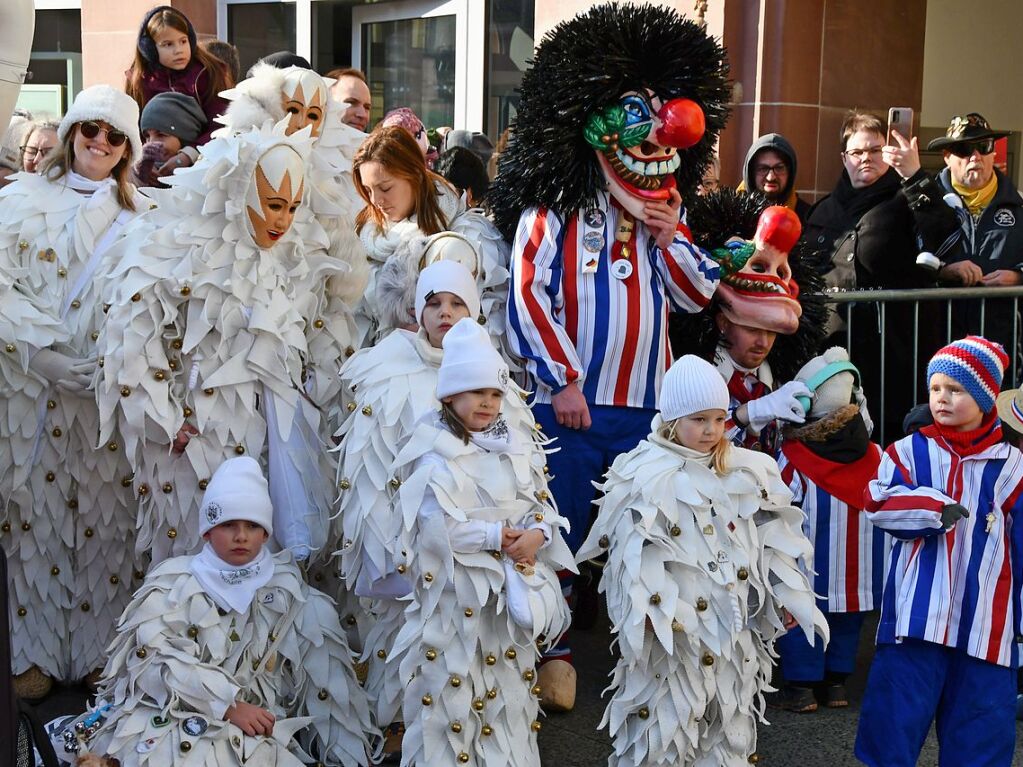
[97,124,339,561]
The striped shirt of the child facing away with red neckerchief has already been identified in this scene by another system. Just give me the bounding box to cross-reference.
[777,444,890,613]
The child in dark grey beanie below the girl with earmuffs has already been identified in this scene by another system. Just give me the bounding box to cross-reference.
[135,92,206,186]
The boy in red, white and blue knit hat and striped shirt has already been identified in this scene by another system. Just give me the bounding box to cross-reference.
[856,335,1023,767]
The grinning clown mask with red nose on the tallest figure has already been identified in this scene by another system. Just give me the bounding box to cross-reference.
[583,91,706,221]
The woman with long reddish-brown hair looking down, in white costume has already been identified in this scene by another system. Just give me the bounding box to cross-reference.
[352,126,508,346]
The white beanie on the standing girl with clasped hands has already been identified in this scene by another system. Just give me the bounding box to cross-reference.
[437,319,508,400]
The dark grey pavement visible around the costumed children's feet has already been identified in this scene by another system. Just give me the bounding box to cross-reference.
[29,616,1023,767]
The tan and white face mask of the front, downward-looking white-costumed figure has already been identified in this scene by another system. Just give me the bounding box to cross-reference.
[246,145,305,249]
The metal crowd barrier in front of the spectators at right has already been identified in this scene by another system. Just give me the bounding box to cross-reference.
[826,286,1023,446]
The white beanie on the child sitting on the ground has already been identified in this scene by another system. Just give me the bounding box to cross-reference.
[198,455,273,536]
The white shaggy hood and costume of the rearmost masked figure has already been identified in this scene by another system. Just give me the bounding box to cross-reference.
[213,63,369,319]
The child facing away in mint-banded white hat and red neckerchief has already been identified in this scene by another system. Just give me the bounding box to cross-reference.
[768,347,891,713]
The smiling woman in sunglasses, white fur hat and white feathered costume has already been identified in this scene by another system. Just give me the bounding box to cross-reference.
[0,85,149,696]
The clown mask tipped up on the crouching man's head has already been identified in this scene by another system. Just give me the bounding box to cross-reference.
[711,206,803,335]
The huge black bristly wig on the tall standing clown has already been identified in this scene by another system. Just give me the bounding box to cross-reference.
[486,3,729,241]
